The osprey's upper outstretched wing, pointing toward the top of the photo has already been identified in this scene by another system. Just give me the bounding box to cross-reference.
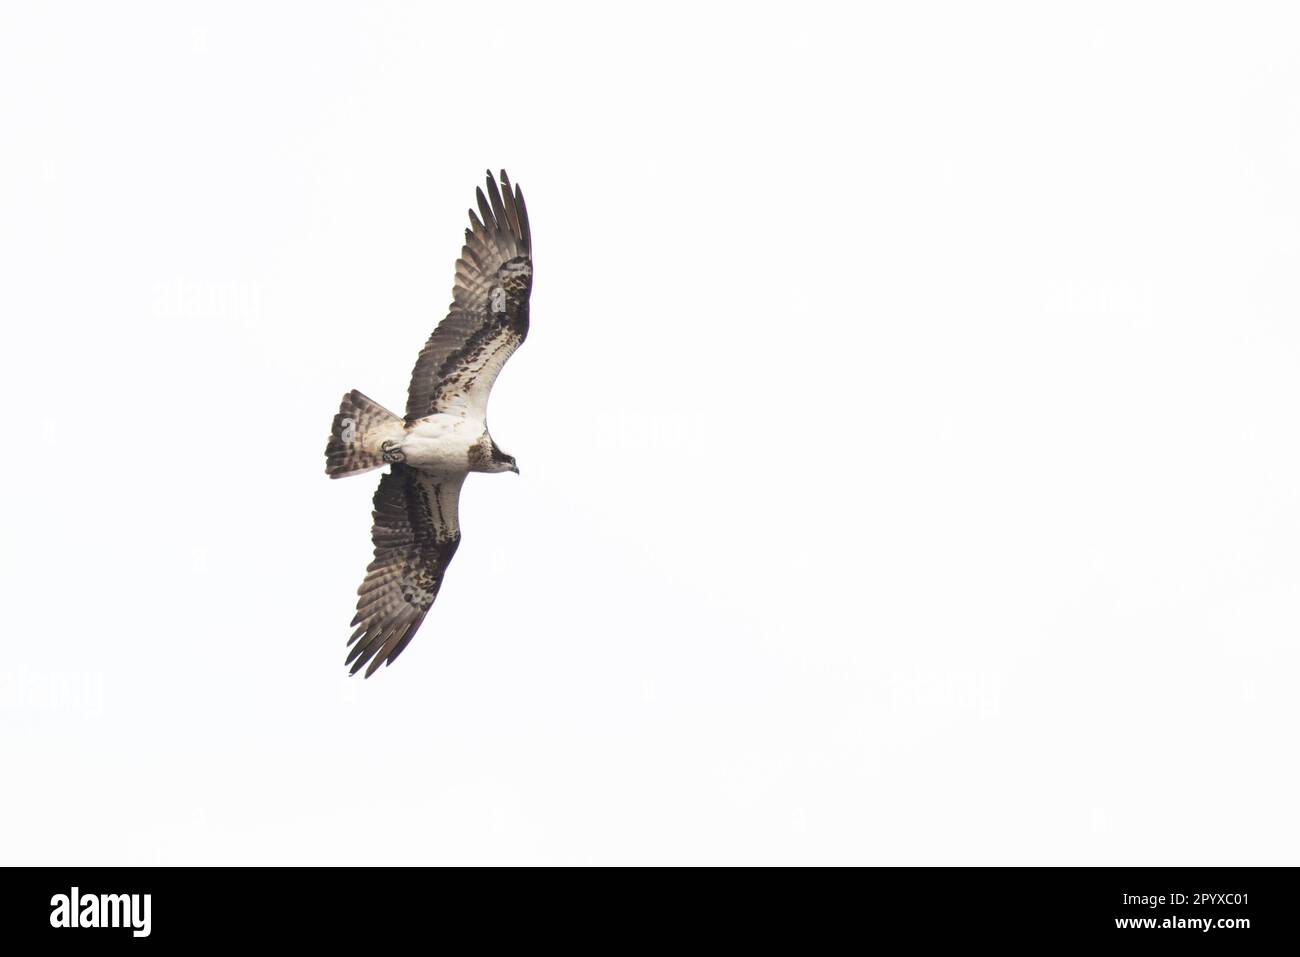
[406,170,533,424]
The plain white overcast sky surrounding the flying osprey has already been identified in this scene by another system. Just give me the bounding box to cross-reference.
[0,3,1300,865]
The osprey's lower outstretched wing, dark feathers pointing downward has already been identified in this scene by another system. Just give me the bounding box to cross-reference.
[347,464,465,677]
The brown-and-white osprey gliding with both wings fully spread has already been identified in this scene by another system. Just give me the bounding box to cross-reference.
[325,170,533,677]
